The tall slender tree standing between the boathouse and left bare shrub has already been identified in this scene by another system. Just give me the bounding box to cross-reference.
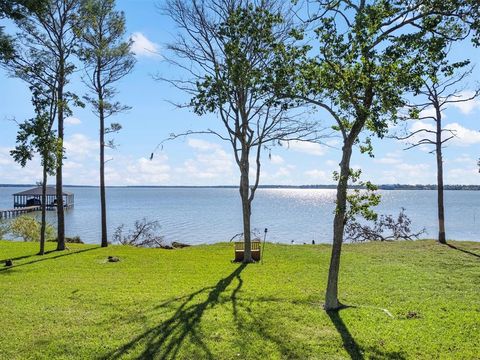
[78,0,135,247]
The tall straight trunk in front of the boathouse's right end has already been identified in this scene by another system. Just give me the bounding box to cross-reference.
[56,60,65,251]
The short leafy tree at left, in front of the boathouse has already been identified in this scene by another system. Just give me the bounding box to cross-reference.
[10,82,58,255]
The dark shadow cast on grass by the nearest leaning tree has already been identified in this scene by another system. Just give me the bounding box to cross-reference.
[327,306,406,360]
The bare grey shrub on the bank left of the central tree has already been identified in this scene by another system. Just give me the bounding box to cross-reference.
[113,218,165,248]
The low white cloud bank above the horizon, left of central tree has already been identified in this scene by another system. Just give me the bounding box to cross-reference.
[0,133,238,185]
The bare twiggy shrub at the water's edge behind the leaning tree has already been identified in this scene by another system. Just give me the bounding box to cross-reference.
[345,208,425,242]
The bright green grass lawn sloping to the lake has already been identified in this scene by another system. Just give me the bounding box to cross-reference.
[0,241,480,359]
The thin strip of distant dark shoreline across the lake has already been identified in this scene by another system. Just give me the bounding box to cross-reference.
[0,184,480,191]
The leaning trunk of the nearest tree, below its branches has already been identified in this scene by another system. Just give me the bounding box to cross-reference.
[325,143,352,311]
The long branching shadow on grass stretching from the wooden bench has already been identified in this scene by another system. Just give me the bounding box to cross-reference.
[101,264,247,359]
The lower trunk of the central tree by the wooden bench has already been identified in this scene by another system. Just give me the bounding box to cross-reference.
[240,151,253,263]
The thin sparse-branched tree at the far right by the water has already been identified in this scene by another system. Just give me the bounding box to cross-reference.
[396,60,480,244]
